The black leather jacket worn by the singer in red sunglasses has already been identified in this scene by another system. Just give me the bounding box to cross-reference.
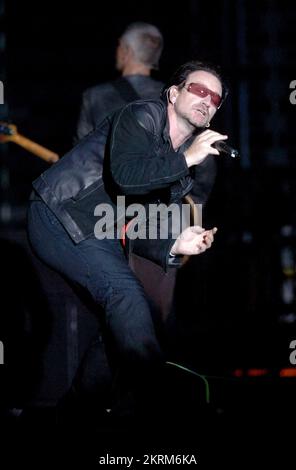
[33,100,215,267]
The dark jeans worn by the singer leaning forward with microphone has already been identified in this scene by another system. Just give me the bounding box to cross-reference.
[28,201,164,414]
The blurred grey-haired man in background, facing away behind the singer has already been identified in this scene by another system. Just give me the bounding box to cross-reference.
[77,22,163,139]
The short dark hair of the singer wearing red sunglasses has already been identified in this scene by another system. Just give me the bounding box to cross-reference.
[161,60,228,104]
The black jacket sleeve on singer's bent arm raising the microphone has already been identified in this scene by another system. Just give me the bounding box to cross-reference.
[110,104,189,195]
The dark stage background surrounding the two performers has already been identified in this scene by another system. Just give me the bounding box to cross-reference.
[0,0,296,462]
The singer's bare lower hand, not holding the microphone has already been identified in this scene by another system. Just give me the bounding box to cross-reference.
[171,225,218,255]
